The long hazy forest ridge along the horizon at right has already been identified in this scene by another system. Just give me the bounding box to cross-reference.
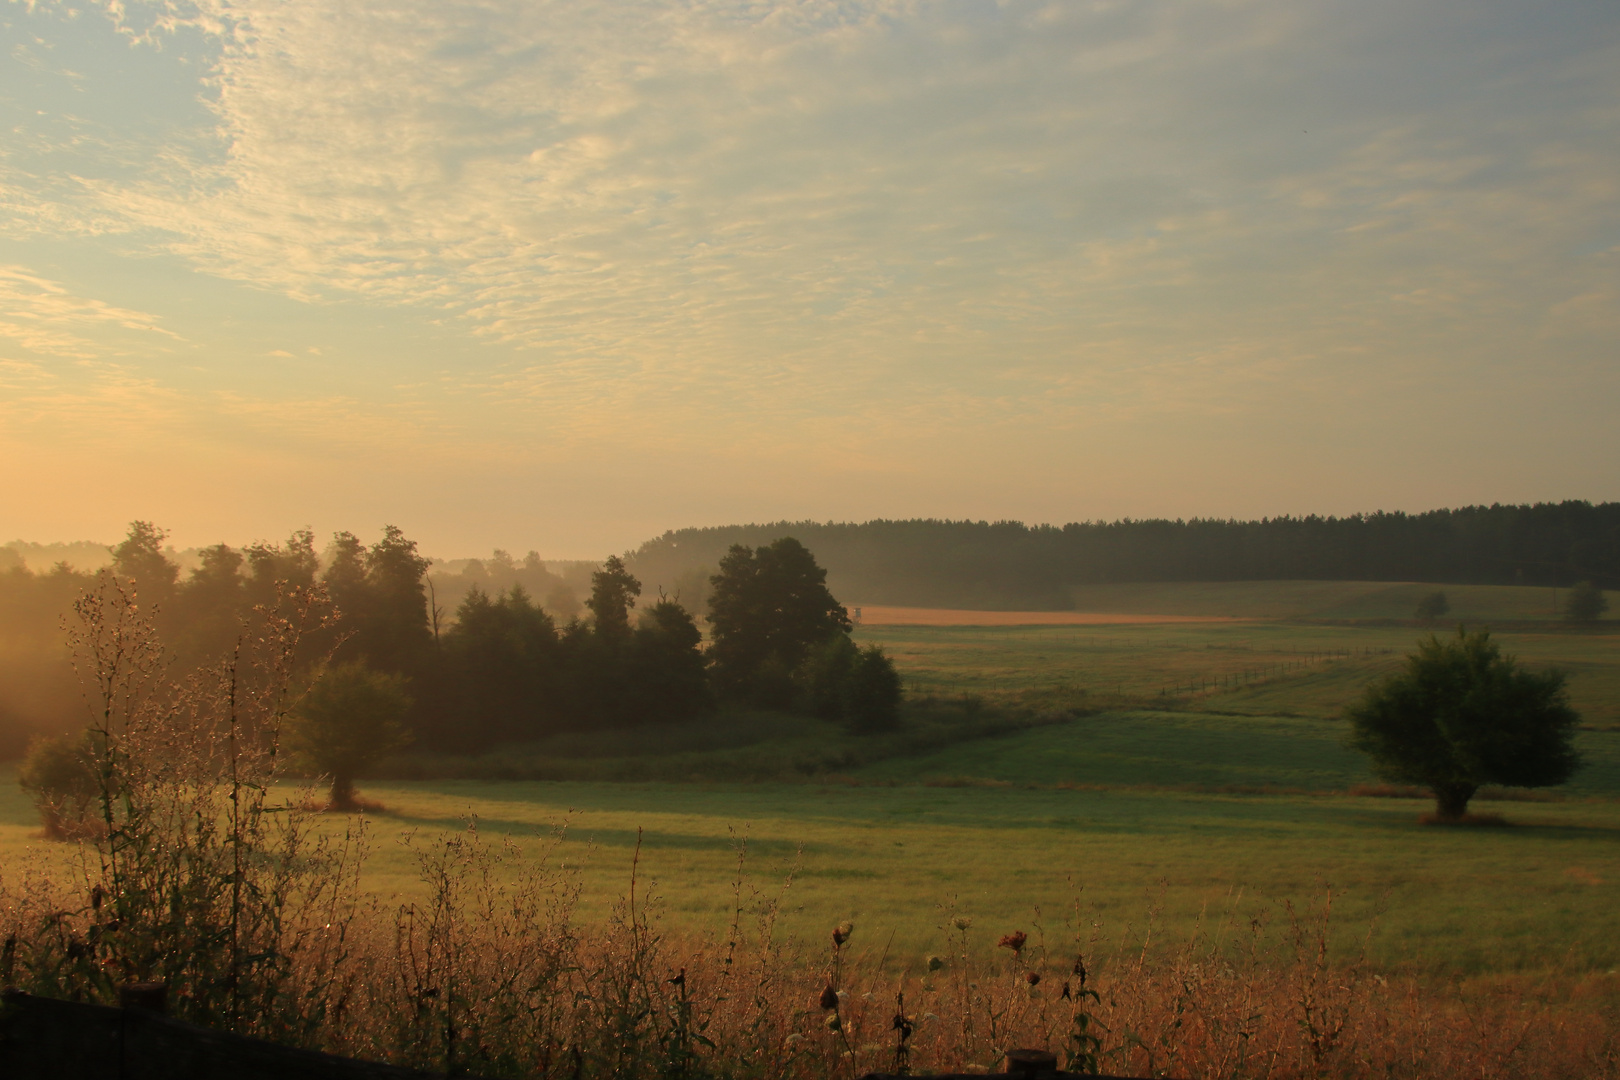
[625,502,1620,610]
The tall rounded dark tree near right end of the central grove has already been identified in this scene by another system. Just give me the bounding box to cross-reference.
[710,536,849,693]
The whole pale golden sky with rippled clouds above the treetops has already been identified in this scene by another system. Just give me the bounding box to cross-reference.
[0,0,1620,557]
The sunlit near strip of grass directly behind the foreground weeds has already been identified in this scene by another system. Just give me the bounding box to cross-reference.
[0,761,1620,973]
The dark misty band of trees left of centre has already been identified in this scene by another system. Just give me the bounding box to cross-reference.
[0,521,901,753]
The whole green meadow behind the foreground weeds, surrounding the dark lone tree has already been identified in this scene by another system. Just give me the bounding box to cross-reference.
[0,583,1620,975]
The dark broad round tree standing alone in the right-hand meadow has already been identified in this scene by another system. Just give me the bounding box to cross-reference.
[1348,630,1581,821]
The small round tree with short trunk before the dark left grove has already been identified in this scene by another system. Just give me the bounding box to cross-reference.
[287,661,411,811]
